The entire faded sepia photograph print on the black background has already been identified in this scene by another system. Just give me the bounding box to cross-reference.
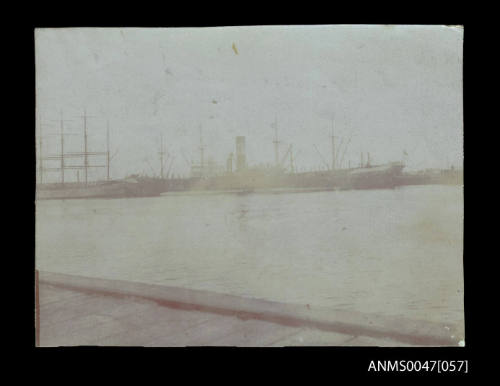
[34,25,465,347]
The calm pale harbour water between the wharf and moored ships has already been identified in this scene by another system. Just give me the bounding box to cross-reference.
[36,186,463,323]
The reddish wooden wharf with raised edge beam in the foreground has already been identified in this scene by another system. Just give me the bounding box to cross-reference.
[37,272,463,347]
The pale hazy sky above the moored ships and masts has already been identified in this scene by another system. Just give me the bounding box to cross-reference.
[35,26,463,179]
